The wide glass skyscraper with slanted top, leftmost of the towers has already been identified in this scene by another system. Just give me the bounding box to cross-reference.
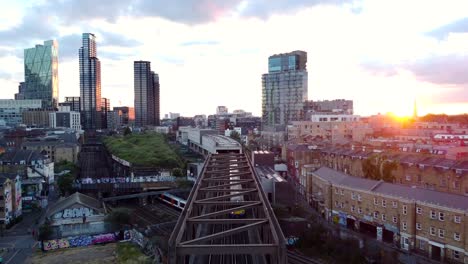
[16,40,59,108]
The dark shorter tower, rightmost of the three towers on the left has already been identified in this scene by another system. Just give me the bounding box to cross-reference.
[133,61,160,127]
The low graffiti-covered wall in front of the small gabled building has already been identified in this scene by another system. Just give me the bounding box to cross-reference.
[42,233,117,251]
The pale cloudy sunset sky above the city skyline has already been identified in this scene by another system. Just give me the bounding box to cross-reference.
[0,0,468,116]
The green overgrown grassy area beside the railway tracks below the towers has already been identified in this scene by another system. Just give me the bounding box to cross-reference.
[104,133,183,169]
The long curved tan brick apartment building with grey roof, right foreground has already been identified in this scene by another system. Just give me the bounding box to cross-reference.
[309,167,468,263]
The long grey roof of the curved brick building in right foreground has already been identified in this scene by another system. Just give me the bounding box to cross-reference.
[313,167,468,211]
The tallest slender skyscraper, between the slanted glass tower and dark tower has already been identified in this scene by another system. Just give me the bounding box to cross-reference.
[79,33,102,129]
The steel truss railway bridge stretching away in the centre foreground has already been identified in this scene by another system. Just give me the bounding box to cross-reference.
[169,153,287,264]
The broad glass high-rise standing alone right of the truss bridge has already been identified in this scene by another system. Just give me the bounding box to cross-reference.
[262,51,308,126]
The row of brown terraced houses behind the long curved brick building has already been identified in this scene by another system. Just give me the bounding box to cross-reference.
[321,148,468,195]
